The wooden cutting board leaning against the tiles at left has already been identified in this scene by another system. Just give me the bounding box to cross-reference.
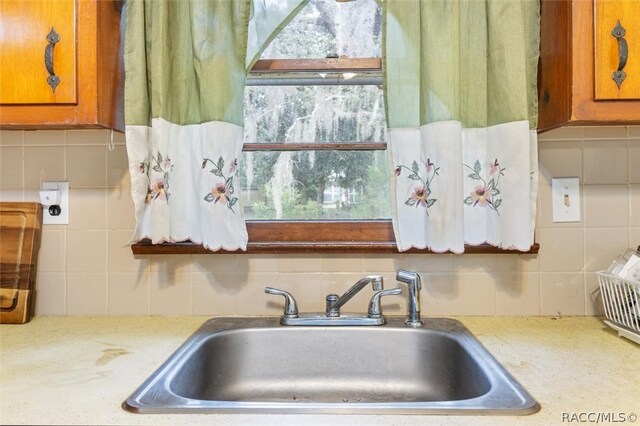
[0,202,42,324]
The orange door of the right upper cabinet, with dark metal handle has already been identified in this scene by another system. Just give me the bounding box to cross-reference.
[595,0,640,100]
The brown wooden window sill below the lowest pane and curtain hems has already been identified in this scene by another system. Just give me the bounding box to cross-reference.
[131,220,540,255]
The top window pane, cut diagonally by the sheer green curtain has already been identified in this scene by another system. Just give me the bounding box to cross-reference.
[262,0,382,59]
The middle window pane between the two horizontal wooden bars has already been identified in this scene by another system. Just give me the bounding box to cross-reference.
[244,86,386,143]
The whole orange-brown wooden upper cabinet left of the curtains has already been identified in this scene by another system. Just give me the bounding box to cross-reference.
[0,0,124,131]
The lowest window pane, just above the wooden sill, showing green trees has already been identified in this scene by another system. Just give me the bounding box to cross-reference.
[240,151,391,219]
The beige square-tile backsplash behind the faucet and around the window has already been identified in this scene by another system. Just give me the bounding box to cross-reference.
[0,126,640,316]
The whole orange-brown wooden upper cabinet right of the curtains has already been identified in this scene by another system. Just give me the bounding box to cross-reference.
[538,0,640,131]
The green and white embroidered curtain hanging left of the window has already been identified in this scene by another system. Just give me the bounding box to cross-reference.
[124,0,250,250]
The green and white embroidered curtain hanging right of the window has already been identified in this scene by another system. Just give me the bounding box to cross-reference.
[384,0,539,253]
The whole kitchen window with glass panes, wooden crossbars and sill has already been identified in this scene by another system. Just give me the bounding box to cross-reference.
[133,0,540,254]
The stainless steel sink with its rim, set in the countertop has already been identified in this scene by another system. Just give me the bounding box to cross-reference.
[123,318,540,415]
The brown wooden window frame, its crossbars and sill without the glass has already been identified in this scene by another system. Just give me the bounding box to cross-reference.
[132,58,539,255]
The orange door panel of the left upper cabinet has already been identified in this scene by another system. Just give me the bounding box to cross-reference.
[0,0,76,104]
